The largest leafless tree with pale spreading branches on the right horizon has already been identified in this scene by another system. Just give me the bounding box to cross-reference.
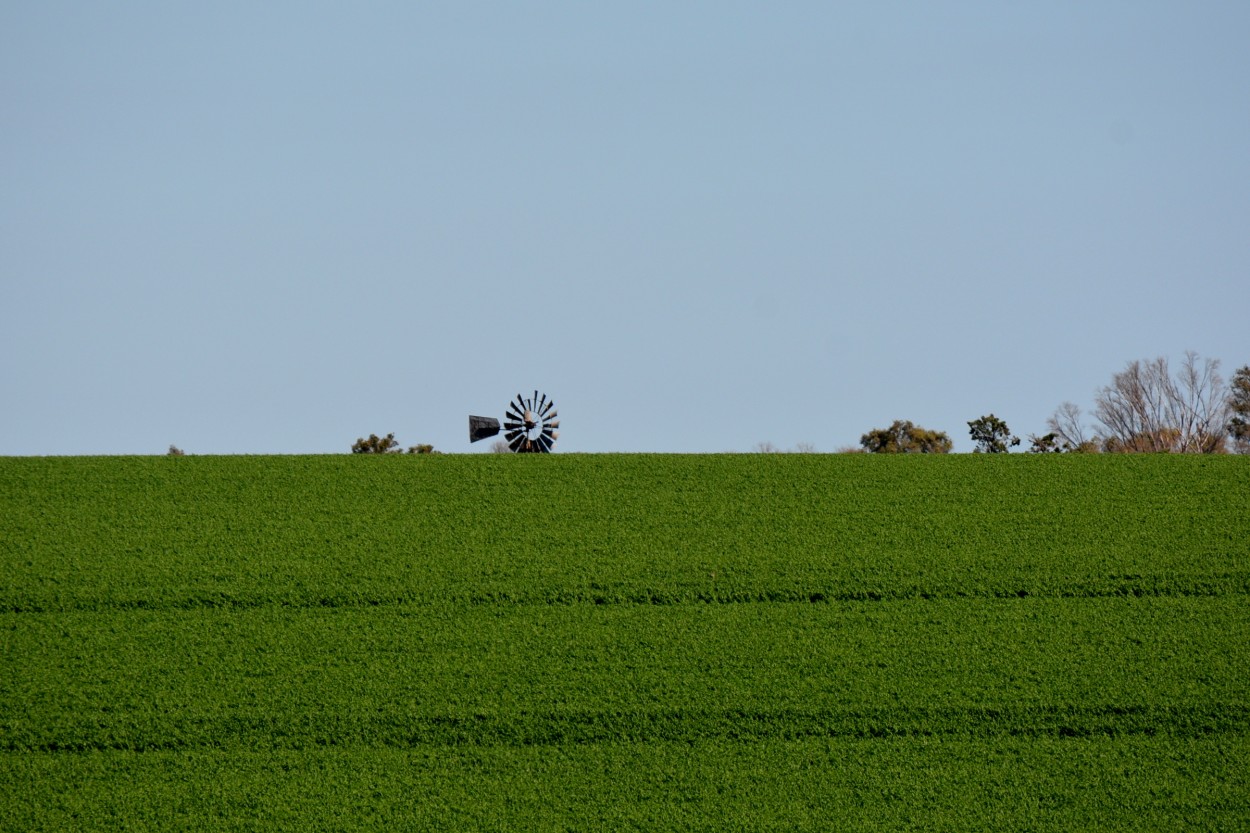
[1095,350,1229,454]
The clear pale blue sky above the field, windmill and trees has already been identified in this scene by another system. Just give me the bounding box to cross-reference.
[0,0,1250,455]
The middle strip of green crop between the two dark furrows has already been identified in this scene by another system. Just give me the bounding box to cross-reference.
[0,598,1250,750]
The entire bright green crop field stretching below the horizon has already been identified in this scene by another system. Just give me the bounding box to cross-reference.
[0,454,1250,830]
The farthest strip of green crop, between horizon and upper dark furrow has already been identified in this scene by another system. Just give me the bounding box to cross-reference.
[0,447,1250,612]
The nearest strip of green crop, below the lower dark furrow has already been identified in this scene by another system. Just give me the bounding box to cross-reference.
[0,735,1250,833]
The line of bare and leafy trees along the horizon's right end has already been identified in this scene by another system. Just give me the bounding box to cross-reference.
[855,351,1250,454]
